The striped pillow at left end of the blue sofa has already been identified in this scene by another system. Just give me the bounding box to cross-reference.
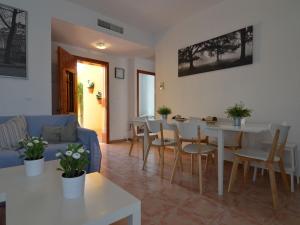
[0,116,27,149]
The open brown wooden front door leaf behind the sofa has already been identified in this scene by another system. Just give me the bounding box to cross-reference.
[57,47,77,114]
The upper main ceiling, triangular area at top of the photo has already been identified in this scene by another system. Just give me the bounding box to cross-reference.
[69,0,224,35]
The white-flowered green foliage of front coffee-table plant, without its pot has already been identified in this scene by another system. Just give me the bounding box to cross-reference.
[56,144,90,178]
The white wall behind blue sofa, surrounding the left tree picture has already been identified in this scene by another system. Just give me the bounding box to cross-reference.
[0,0,51,115]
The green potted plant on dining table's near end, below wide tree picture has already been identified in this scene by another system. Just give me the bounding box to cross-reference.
[225,102,252,126]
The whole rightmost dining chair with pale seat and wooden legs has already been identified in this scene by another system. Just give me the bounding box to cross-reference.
[228,125,290,208]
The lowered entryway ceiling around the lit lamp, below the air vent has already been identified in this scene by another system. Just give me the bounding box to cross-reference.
[51,19,154,58]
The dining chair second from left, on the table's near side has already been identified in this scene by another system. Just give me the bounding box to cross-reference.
[143,120,179,177]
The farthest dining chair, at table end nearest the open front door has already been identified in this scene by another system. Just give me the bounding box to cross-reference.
[129,119,157,160]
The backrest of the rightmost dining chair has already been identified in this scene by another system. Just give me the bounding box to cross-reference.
[268,124,290,161]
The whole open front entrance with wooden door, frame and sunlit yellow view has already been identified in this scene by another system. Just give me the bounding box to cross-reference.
[54,47,110,143]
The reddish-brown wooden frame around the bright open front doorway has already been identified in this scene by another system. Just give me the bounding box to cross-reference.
[74,55,110,144]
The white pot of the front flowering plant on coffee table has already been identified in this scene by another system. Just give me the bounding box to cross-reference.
[61,172,86,199]
